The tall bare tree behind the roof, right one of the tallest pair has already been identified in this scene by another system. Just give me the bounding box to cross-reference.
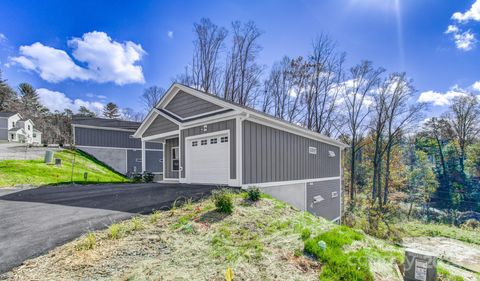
[223,21,262,105]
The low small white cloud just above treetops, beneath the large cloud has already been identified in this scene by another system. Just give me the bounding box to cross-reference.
[37,88,104,115]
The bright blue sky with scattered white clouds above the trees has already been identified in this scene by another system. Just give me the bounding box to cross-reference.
[0,0,480,116]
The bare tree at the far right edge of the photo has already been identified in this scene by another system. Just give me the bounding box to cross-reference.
[448,94,480,173]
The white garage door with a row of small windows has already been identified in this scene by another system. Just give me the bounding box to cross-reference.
[185,134,230,184]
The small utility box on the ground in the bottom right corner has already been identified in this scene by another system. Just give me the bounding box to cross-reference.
[404,249,437,281]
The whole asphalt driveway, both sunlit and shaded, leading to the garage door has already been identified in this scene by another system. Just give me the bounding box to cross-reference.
[0,183,215,273]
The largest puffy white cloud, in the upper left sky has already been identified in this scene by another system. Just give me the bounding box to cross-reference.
[10,31,146,85]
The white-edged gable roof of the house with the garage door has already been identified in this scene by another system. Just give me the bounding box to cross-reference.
[134,83,347,148]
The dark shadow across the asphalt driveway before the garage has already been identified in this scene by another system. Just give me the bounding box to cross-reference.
[0,183,216,214]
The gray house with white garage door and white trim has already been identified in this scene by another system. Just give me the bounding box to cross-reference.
[133,84,345,220]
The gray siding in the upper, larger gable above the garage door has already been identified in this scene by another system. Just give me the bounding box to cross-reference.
[165,91,222,118]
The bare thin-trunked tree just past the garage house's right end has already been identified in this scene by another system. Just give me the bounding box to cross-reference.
[342,61,384,202]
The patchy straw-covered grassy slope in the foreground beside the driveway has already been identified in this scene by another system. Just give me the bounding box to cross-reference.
[1,192,401,280]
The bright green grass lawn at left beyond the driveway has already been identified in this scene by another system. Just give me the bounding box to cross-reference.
[0,150,129,187]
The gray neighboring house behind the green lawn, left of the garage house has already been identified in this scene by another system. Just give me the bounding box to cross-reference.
[72,116,163,175]
